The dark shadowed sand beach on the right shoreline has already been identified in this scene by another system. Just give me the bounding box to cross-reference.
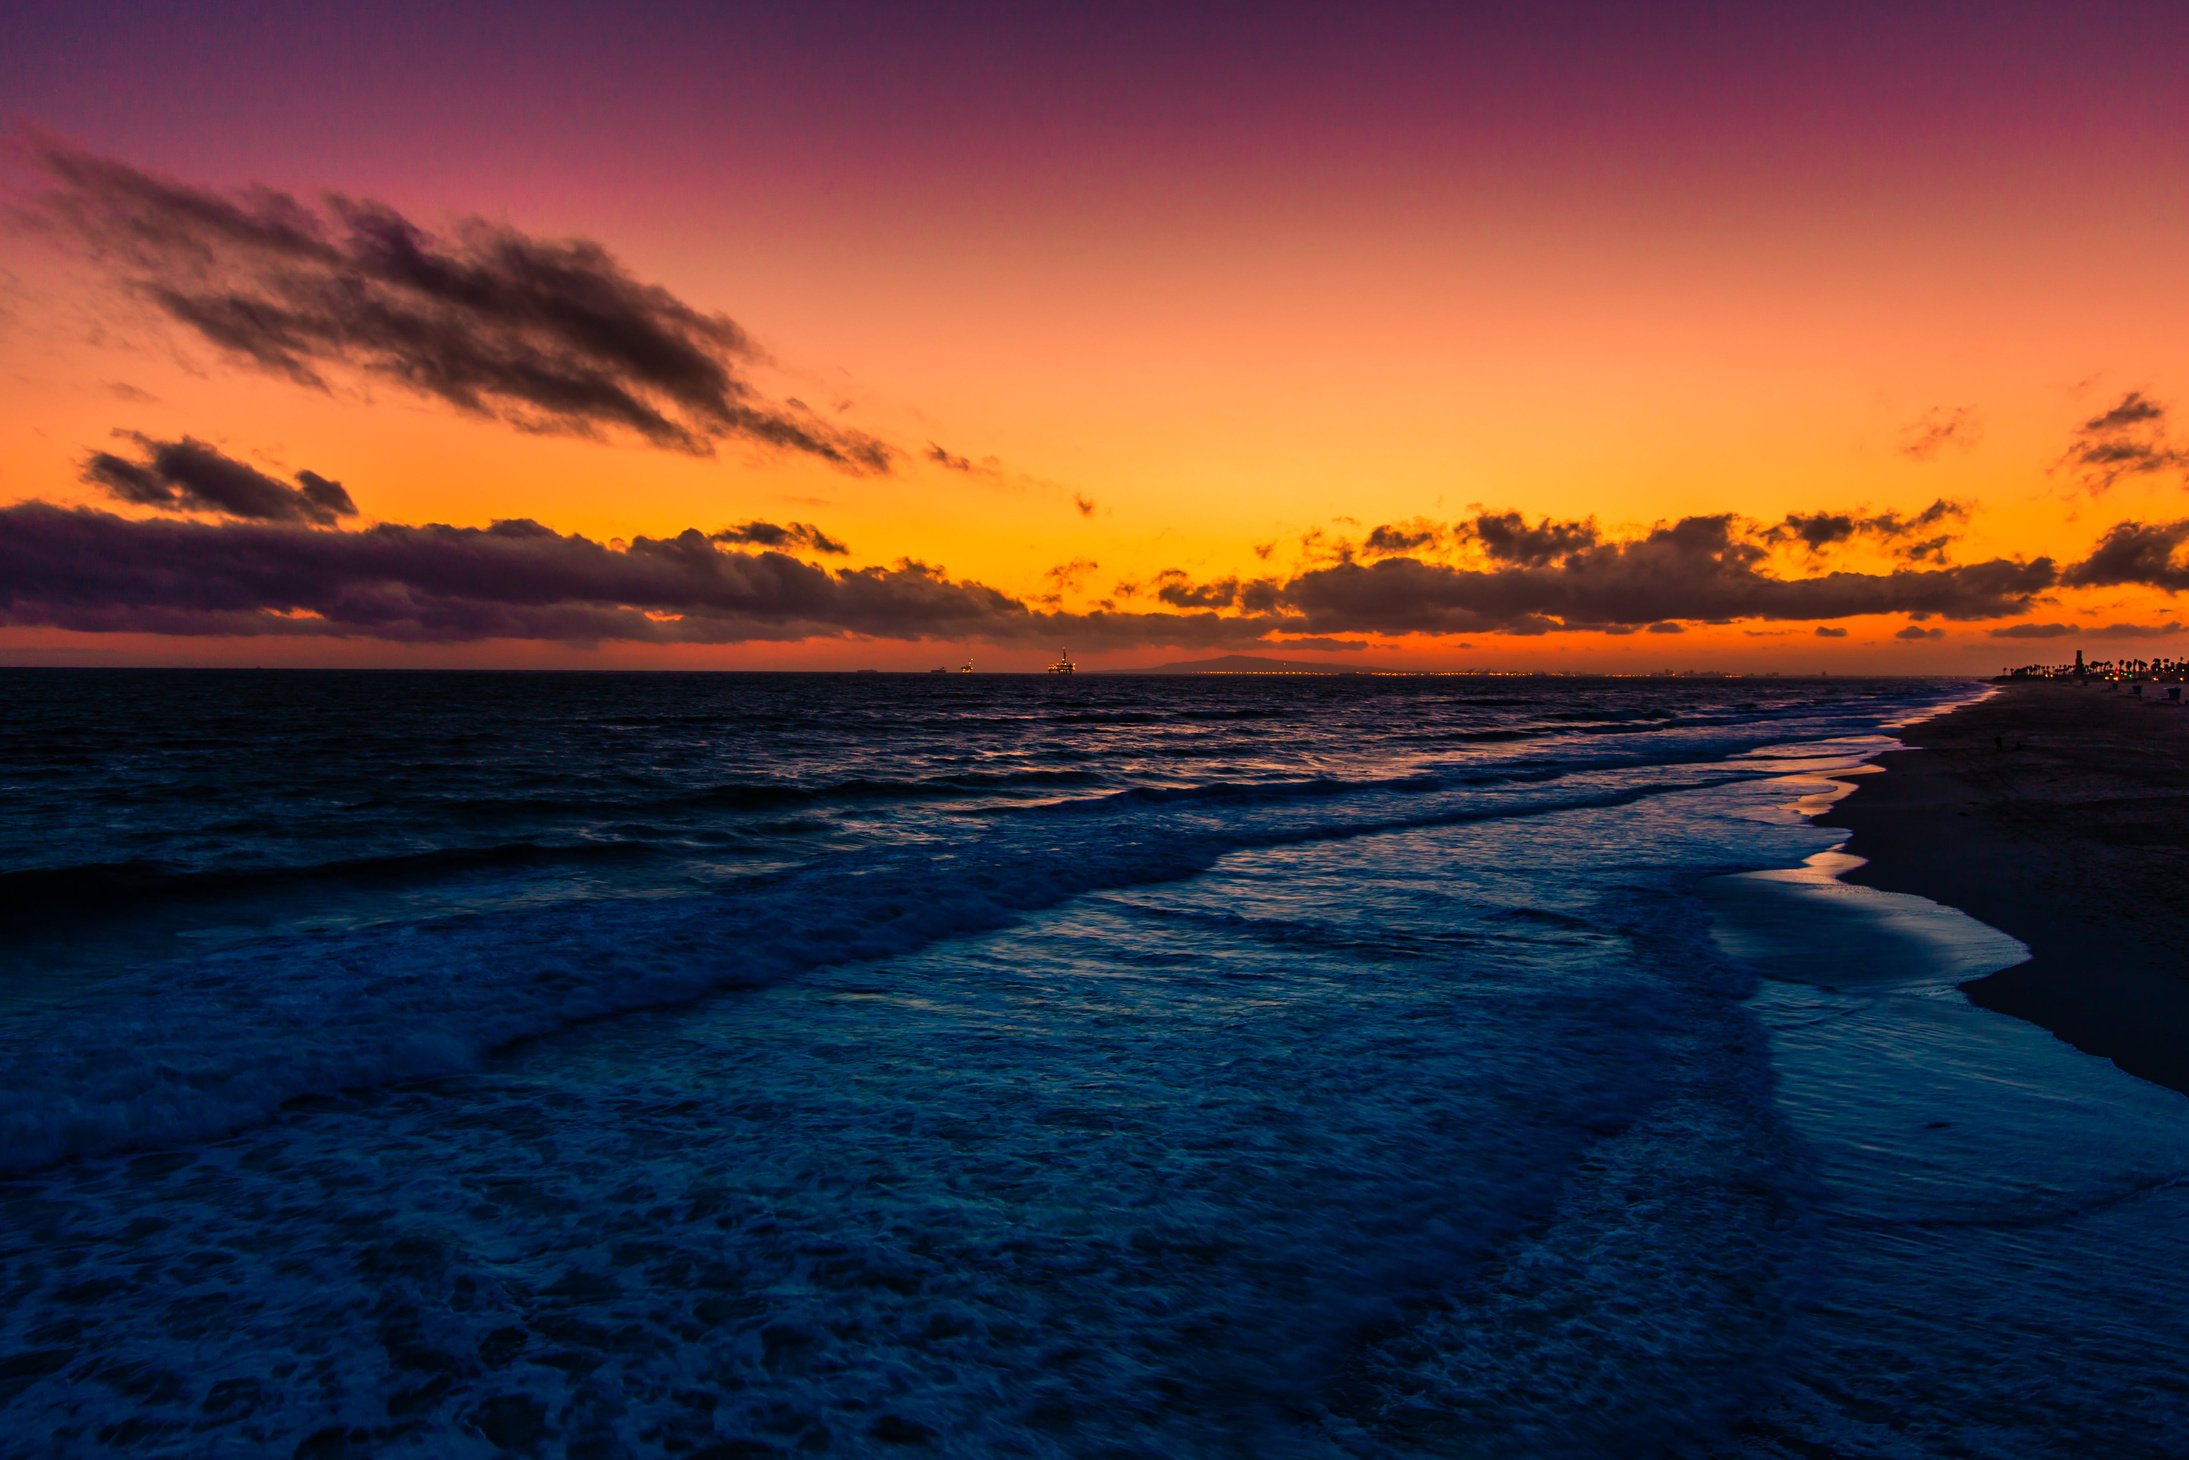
[1823,681,2189,1094]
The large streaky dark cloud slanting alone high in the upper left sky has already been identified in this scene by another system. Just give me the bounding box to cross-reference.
[37,144,891,473]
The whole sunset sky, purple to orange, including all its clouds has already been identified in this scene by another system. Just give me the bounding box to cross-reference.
[0,2,2189,672]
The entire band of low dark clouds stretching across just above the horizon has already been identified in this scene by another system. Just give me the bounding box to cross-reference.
[0,494,2110,650]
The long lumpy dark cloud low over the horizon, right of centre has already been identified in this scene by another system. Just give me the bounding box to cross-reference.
[1285,514,2058,633]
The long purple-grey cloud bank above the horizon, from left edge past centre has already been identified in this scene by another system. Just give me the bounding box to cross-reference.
[0,501,1302,648]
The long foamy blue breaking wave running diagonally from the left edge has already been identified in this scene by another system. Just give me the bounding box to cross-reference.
[0,748,1794,1173]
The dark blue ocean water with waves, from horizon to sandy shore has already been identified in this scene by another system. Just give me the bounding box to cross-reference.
[0,672,2189,1456]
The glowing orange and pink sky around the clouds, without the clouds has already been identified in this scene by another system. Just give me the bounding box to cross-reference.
[0,1,2189,672]
